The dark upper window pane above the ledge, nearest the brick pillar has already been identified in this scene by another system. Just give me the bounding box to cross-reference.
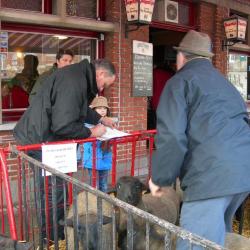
[66,0,97,18]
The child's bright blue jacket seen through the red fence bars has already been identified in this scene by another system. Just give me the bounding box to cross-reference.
[77,141,112,170]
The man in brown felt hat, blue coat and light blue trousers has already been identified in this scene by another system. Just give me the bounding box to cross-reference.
[149,30,250,249]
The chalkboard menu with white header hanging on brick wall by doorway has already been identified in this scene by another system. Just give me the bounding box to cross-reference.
[132,40,153,96]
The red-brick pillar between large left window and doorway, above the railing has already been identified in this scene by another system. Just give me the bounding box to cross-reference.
[105,0,149,132]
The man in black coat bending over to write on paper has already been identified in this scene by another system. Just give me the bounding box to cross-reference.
[14,59,115,240]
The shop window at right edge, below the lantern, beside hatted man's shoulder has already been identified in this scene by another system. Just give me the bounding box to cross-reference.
[228,53,248,100]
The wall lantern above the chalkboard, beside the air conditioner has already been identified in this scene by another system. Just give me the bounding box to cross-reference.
[124,0,155,38]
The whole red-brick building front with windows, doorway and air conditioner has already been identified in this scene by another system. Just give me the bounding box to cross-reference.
[0,0,250,134]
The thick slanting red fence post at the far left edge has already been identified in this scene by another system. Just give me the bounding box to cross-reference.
[0,149,17,240]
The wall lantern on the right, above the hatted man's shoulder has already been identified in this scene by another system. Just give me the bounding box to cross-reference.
[222,15,247,50]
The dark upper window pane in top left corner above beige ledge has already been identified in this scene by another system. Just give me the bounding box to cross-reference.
[1,0,43,12]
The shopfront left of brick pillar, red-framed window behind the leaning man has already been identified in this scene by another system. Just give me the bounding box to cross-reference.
[0,0,114,127]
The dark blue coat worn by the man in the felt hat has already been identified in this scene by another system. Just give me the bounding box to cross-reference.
[152,58,250,201]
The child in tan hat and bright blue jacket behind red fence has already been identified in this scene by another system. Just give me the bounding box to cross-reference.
[77,96,112,193]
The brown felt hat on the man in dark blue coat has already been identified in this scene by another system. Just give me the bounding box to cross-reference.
[174,30,214,57]
